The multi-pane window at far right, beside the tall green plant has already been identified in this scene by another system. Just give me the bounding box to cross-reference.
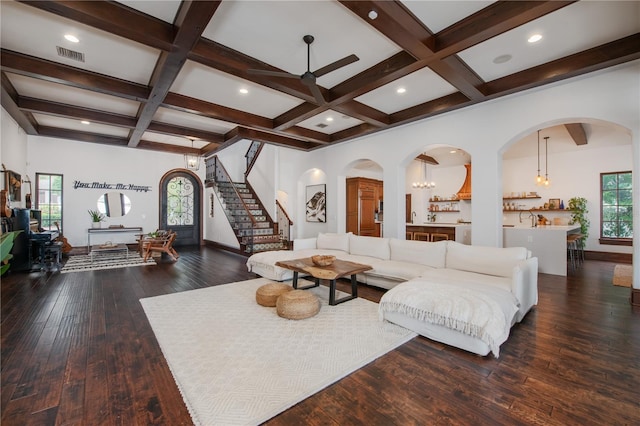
[600,172,633,244]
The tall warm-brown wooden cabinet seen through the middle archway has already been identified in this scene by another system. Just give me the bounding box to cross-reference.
[346,177,384,237]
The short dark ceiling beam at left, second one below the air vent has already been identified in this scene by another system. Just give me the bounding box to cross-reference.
[18,96,136,129]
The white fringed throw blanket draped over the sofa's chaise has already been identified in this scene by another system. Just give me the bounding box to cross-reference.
[378,278,518,358]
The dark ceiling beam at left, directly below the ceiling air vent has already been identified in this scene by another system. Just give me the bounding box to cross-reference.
[0,49,149,102]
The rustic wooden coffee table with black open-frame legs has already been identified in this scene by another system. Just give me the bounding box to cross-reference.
[276,257,373,305]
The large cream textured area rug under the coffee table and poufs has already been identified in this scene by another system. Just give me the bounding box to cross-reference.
[140,278,416,425]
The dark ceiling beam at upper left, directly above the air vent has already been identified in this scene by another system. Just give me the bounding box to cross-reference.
[18,0,174,51]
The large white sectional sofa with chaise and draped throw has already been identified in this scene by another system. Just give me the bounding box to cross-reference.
[247,233,538,357]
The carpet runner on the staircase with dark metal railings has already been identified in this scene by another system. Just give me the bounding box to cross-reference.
[215,182,287,253]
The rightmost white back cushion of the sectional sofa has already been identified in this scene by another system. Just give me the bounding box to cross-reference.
[445,241,527,277]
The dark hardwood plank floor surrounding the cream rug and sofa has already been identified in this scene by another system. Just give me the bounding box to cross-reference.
[1,248,640,426]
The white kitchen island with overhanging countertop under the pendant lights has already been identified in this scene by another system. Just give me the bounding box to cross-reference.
[503,224,580,276]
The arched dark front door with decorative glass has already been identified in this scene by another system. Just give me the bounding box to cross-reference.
[159,170,202,246]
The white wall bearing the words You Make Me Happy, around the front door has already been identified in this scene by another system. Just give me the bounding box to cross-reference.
[26,136,207,246]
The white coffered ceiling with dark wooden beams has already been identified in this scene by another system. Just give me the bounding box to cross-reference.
[0,0,640,156]
